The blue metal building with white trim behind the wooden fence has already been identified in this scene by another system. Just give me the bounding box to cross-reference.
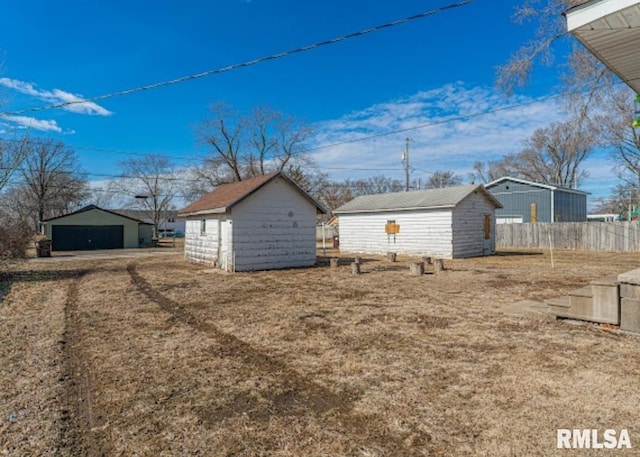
[485,176,588,224]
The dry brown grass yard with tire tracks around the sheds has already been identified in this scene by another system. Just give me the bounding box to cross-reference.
[0,251,640,457]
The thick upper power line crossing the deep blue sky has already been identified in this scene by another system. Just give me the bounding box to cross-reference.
[0,0,475,117]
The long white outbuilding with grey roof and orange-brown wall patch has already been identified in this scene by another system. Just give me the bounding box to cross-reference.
[334,185,502,259]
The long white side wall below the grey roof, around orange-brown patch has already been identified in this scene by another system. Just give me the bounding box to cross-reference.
[339,209,453,258]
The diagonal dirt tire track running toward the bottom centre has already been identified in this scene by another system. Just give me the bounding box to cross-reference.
[127,263,431,456]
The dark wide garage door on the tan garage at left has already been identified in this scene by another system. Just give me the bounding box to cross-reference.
[51,225,124,251]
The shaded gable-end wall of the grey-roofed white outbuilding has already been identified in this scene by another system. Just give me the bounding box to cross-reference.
[453,192,496,258]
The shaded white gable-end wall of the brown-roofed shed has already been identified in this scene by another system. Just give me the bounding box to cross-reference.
[232,178,316,271]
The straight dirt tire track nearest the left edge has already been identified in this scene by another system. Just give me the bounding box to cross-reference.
[57,271,110,456]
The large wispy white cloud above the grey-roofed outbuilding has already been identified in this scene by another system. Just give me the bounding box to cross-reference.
[312,83,562,179]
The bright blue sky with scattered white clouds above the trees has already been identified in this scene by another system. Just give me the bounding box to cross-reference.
[0,0,610,207]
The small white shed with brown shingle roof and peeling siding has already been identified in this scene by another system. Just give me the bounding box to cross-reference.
[178,172,326,271]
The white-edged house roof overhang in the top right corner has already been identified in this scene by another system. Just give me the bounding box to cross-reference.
[565,0,640,93]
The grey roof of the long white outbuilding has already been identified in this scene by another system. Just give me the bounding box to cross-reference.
[333,184,502,214]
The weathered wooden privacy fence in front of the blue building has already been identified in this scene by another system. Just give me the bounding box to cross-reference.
[496,222,640,252]
